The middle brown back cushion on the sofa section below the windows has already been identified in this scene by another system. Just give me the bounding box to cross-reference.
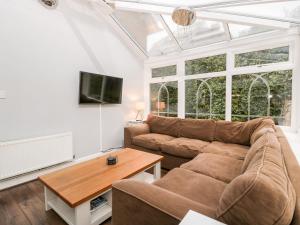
[179,119,216,142]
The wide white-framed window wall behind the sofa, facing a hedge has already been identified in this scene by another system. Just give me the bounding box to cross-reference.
[146,44,295,126]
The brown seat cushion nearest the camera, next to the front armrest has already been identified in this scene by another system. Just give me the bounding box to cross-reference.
[154,168,226,209]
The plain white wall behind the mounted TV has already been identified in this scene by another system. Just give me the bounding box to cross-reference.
[0,0,143,158]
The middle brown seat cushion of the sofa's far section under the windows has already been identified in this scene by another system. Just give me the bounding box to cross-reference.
[161,138,210,159]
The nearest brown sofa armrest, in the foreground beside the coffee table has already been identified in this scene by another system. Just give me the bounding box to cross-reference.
[112,180,216,225]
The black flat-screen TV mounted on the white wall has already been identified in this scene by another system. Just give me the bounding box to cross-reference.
[79,72,123,104]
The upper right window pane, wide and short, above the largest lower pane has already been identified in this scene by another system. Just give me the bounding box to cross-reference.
[235,46,289,67]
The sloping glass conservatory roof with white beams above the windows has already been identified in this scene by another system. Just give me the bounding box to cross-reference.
[107,0,300,56]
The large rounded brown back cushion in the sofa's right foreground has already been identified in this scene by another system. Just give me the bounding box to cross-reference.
[217,133,296,225]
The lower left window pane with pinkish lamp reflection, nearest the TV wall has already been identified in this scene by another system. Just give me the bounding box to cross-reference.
[150,81,178,117]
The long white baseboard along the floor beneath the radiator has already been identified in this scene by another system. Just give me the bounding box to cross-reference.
[0,149,120,190]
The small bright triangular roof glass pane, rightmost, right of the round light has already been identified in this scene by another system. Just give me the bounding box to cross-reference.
[228,23,272,38]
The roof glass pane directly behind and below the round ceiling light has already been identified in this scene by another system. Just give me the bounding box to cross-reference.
[163,15,227,49]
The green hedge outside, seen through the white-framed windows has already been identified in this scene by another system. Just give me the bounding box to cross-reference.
[150,47,292,126]
